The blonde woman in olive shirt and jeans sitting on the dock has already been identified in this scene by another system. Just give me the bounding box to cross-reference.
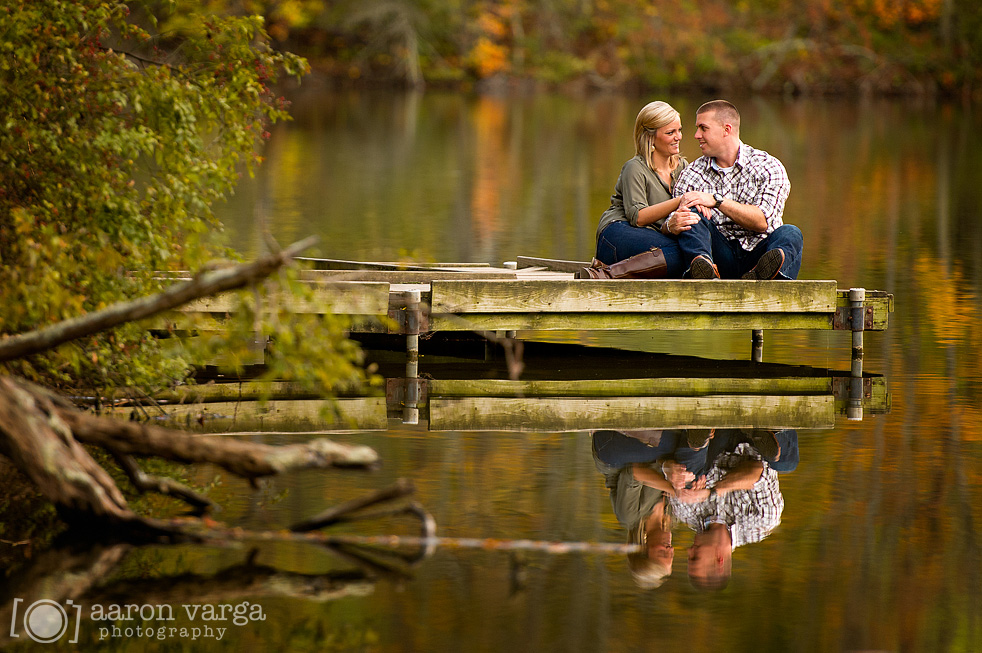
[596,101,698,278]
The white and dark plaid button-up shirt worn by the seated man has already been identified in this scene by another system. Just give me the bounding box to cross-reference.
[673,143,791,252]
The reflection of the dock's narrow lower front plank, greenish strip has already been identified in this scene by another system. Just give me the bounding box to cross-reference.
[427,376,832,398]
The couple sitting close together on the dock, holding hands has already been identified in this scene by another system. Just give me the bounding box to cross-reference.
[596,100,802,280]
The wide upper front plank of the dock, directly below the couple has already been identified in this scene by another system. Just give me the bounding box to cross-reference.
[431,279,836,313]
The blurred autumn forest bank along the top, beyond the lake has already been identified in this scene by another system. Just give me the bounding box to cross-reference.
[186,0,982,97]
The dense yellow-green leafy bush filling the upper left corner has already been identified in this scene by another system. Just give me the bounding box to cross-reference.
[0,0,368,398]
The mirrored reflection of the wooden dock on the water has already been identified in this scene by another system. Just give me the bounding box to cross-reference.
[140,340,890,432]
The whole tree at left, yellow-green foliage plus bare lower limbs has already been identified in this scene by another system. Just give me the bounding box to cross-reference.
[0,0,375,535]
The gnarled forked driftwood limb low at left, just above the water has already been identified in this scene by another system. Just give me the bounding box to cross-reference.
[0,377,378,541]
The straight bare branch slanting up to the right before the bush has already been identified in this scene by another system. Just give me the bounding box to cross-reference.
[0,237,317,362]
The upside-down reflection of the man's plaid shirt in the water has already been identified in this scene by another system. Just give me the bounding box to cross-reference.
[669,442,784,549]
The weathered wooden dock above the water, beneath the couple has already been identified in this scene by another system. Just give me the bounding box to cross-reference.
[171,257,894,366]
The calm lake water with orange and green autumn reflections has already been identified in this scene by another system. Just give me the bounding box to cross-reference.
[3,88,982,652]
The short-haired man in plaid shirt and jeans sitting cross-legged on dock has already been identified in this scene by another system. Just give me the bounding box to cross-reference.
[668,100,802,280]
